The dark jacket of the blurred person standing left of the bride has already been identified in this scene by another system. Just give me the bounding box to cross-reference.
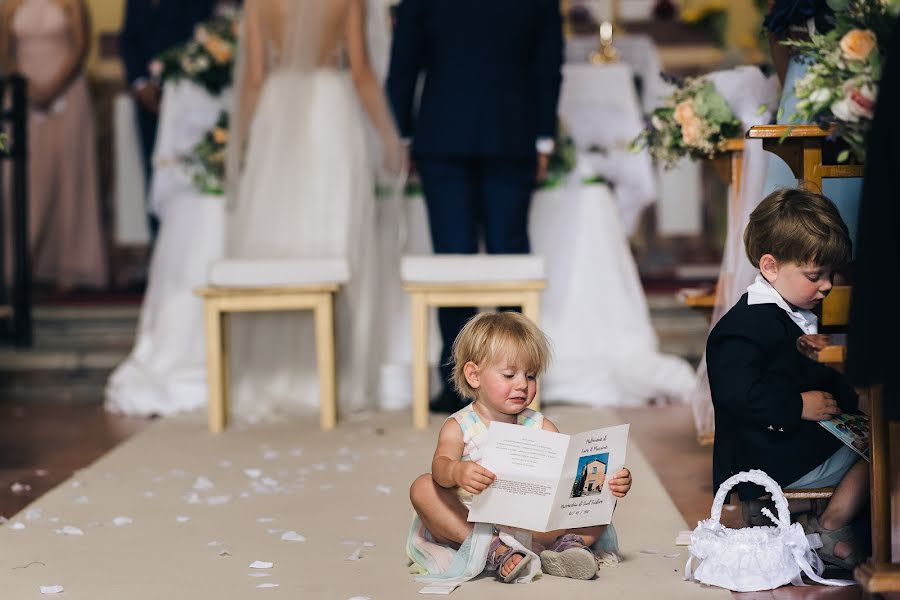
[119,0,215,84]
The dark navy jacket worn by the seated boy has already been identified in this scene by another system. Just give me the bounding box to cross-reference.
[706,294,857,500]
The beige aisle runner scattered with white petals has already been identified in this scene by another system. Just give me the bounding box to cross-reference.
[0,407,730,600]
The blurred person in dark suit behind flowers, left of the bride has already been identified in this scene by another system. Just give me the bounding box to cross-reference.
[119,0,216,237]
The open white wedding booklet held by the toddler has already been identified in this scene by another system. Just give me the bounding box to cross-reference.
[469,422,628,531]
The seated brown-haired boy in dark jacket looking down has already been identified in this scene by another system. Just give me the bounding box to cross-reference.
[706,189,869,568]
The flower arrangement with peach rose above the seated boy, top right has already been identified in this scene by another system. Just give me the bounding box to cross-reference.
[782,0,896,162]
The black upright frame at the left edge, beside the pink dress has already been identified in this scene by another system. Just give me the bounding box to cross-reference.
[0,76,33,346]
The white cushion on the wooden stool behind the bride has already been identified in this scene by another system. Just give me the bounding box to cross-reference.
[209,258,350,287]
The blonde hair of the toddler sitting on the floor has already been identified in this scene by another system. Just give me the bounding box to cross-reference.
[452,312,550,400]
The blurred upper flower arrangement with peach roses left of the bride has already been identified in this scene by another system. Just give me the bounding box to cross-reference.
[150,11,240,96]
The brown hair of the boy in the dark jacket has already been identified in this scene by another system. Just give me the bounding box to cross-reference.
[744,188,852,269]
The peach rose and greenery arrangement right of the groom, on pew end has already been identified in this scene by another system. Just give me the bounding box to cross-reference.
[631,77,743,168]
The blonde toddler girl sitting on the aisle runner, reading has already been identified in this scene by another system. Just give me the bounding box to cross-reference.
[406,312,631,583]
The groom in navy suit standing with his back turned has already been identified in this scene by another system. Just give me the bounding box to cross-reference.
[387,0,563,412]
